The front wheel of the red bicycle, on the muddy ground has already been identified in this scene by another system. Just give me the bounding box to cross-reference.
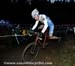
[22,42,39,61]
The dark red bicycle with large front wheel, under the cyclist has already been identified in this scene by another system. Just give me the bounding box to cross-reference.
[22,32,52,61]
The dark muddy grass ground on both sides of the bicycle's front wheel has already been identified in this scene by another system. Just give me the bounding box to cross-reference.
[0,36,75,66]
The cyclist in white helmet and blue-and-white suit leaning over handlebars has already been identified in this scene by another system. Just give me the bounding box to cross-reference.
[31,8,58,39]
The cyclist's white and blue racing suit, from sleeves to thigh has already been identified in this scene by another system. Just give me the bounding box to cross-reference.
[32,14,54,36]
